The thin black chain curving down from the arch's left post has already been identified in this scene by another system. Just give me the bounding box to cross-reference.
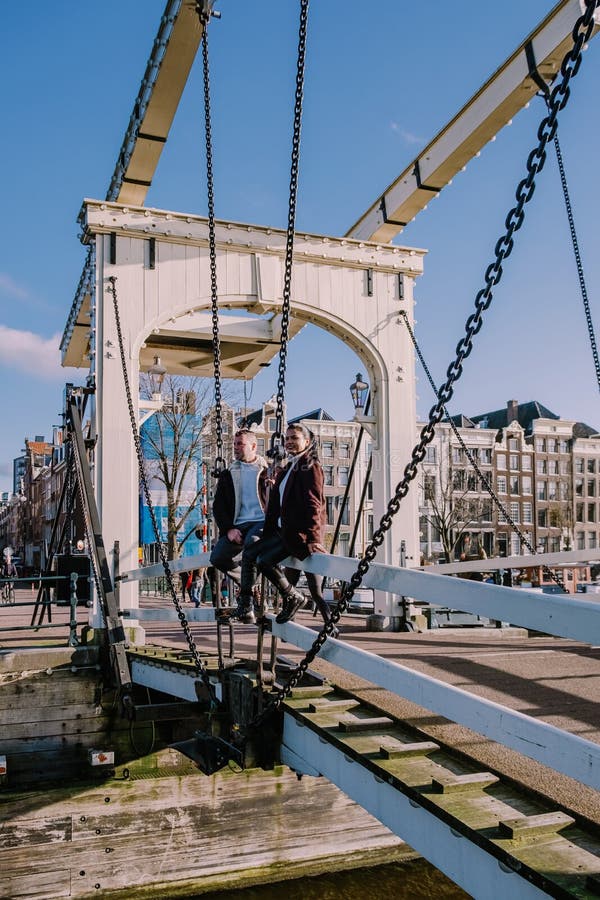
[108,275,218,706]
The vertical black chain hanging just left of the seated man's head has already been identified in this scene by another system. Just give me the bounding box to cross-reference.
[202,22,225,478]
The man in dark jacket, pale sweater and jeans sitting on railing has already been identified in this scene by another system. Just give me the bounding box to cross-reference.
[210,428,269,624]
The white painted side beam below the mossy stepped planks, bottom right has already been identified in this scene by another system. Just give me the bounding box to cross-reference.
[283,714,547,900]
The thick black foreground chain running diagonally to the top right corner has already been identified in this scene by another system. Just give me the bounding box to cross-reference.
[247,0,600,729]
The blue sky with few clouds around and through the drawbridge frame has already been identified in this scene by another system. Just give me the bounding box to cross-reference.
[0,0,600,490]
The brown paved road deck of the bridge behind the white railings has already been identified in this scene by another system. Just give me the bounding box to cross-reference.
[130,599,600,826]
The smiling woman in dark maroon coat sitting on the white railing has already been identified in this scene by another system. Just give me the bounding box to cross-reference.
[239,423,330,625]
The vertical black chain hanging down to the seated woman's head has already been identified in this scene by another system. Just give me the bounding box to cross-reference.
[269,0,308,458]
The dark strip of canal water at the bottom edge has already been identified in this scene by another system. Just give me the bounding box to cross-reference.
[189,859,470,900]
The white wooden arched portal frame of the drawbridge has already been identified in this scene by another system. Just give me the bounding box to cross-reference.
[67,201,424,615]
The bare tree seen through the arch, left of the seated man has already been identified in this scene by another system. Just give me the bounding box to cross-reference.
[140,375,241,559]
